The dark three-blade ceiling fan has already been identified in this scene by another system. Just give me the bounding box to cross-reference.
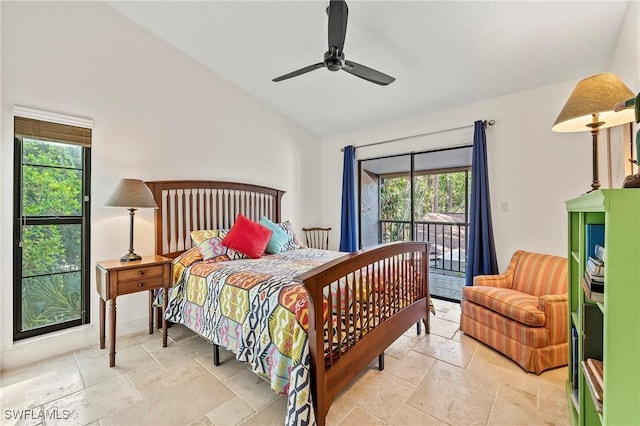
[273,0,395,86]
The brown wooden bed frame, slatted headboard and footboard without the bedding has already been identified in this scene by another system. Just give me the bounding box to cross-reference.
[147,180,429,425]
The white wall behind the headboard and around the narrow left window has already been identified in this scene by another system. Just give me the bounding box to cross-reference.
[0,2,320,369]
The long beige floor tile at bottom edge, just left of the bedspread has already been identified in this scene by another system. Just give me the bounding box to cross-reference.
[100,368,234,426]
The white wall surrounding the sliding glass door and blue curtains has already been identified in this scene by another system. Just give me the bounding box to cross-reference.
[321,2,640,270]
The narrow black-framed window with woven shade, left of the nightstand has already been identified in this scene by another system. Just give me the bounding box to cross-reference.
[13,116,91,340]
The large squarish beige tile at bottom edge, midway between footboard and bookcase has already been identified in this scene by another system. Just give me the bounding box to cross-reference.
[407,362,498,425]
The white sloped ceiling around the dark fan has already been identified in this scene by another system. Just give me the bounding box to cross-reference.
[108,0,627,138]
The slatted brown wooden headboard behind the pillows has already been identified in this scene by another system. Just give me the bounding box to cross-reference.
[146,180,285,258]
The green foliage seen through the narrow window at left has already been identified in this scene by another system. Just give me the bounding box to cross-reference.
[21,139,82,330]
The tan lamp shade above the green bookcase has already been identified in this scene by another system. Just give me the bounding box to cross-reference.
[551,73,634,132]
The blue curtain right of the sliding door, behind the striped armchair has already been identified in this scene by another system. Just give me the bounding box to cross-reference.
[466,120,498,285]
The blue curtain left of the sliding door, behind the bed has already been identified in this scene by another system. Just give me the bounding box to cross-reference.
[340,145,358,252]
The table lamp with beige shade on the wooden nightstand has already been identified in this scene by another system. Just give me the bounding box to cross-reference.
[104,179,158,262]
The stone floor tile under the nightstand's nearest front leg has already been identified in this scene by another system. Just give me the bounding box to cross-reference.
[76,345,155,387]
